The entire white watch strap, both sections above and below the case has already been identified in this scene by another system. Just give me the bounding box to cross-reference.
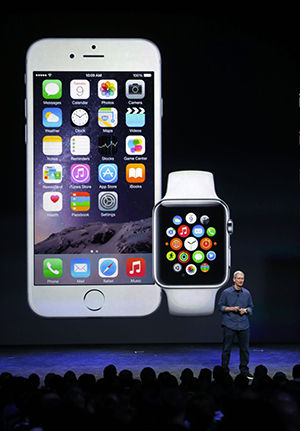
[163,171,218,316]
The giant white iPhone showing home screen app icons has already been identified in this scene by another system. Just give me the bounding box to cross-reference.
[26,39,161,317]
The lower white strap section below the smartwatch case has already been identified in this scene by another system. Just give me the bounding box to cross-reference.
[165,287,218,316]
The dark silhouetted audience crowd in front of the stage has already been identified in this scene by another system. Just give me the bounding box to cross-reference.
[0,364,300,431]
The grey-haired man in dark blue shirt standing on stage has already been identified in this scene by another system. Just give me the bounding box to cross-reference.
[218,271,253,379]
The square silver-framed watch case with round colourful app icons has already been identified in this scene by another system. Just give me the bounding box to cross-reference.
[155,200,229,287]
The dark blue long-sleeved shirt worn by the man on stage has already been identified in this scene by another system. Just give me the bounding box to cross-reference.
[218,286,253,331]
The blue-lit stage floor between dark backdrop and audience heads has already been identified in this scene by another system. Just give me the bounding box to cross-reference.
[0,344,300,379]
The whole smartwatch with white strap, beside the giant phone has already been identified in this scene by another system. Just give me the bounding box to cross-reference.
[153,171,233,316]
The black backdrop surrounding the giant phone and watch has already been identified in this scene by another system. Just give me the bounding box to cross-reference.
[0,10,300,345]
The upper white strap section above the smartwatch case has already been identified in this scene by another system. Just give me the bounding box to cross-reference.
[163,171,218,199]
